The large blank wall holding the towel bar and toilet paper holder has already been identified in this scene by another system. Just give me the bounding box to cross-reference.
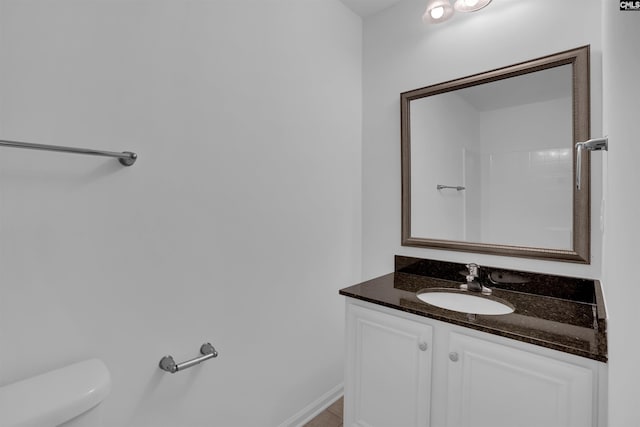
[0,0,362,427]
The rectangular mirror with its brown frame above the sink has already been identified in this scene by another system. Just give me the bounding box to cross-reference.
[400,46,591,264]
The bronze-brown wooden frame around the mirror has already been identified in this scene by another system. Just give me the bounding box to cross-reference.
[400,46,591,264]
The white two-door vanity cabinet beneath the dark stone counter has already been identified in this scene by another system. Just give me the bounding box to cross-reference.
[344,298,606,427]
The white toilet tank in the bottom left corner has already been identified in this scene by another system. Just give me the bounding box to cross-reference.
[0,359,111,427]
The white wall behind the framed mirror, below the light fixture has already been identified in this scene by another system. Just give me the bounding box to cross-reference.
[362,0,602,278]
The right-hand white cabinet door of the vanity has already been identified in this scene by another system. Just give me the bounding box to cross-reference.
[447,333,594,427]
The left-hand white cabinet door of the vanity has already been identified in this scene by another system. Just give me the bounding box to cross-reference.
[345,304,432,427]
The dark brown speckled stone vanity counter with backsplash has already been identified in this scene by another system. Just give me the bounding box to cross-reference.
[340,256,607,362]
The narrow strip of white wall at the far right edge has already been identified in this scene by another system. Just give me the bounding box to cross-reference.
[603,0,640,427]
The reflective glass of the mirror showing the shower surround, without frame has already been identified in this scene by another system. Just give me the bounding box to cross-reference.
[410,65,573,250]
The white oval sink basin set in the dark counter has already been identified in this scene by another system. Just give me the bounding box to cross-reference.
[417,289,515,314]
